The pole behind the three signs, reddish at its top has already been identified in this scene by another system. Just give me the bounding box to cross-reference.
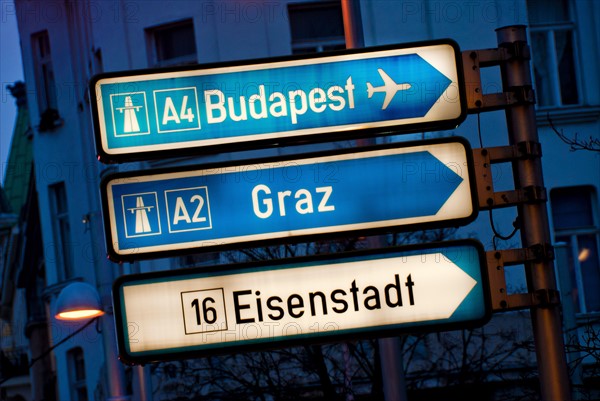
[342,0,408,401]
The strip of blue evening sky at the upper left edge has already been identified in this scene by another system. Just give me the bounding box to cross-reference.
[0,0,23,181]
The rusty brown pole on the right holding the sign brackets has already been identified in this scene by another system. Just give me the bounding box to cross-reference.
[496,25,571,401]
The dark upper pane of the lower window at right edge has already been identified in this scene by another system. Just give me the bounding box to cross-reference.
[550,187,594,230]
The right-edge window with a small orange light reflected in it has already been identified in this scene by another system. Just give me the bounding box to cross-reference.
[550,186,600,313]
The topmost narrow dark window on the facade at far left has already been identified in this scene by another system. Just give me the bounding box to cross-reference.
[32,31,60,131]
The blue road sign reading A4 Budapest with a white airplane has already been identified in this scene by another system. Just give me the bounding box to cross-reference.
[90,40,466,162]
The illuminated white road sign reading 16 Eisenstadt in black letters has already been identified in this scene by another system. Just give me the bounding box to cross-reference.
[113,241,490,363]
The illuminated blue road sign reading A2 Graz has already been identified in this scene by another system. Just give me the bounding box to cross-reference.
[101,138,477,261]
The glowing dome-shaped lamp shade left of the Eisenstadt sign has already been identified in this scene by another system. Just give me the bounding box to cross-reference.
[54,282,104,320]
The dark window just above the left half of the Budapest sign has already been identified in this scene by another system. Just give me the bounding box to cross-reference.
[146,20,198,67]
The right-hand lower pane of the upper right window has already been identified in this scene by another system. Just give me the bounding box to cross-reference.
[554,30,579,104]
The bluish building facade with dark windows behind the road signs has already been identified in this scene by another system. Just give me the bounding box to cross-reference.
[6,0,600,400]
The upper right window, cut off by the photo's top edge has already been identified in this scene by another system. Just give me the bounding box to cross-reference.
[527,0,581,107]
